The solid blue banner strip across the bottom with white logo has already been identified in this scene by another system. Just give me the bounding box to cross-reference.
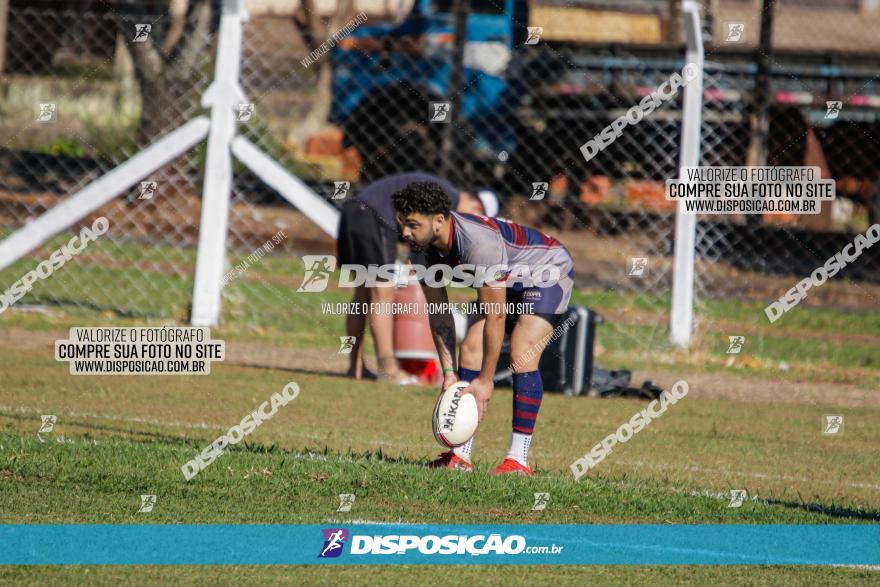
[0,524,880,565]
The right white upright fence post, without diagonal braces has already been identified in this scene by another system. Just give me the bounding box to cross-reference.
[669,0,703,348]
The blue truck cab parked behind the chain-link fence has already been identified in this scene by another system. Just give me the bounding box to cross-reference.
[331,0,528,186]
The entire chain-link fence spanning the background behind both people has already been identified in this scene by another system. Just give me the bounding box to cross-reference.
[0,0,880,346]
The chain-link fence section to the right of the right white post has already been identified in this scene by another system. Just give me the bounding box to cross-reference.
[697,0,880,308]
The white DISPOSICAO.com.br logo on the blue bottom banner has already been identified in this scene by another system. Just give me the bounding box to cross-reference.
[318,528,564,558]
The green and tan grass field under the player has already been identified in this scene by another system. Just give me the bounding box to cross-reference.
[0,241,880,585]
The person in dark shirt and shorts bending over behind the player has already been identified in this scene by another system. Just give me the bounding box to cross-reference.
[337,171,484,385]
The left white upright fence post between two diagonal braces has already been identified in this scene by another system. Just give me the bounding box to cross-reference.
[191,0,245,326]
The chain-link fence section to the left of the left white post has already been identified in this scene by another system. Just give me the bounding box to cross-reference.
[0,2,216,318]
